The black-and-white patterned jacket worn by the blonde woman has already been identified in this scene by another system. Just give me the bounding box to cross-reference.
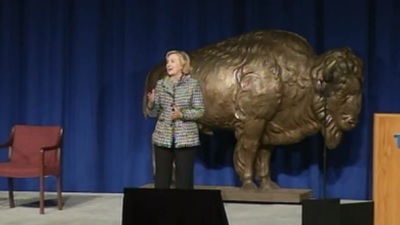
[149,75,204,148]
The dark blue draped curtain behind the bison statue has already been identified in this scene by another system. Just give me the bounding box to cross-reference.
[0,0,400,199]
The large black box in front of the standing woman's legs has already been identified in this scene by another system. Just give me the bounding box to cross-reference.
[122,188,228,225]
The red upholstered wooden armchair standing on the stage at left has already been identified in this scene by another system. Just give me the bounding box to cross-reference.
[0,125,63,214]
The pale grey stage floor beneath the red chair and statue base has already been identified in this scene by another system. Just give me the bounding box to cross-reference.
[0,191,301,225]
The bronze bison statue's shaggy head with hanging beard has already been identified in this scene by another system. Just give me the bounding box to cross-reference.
[312,48,363,149]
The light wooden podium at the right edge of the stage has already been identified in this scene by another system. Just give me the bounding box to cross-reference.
[373,113,400,225]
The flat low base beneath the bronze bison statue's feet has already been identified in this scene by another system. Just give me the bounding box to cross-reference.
[141,184,312,203]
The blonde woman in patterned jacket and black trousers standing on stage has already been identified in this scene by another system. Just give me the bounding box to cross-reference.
[147,50,204,189]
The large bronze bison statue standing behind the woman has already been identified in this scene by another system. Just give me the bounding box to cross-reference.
[143,30,363,190]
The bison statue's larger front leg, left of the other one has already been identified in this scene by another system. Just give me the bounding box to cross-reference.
[234,119,264,190]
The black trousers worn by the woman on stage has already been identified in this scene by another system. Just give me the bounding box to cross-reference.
[154,146,197,189]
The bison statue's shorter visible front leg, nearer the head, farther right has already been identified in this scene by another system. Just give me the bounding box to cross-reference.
[256,146,280,190]
